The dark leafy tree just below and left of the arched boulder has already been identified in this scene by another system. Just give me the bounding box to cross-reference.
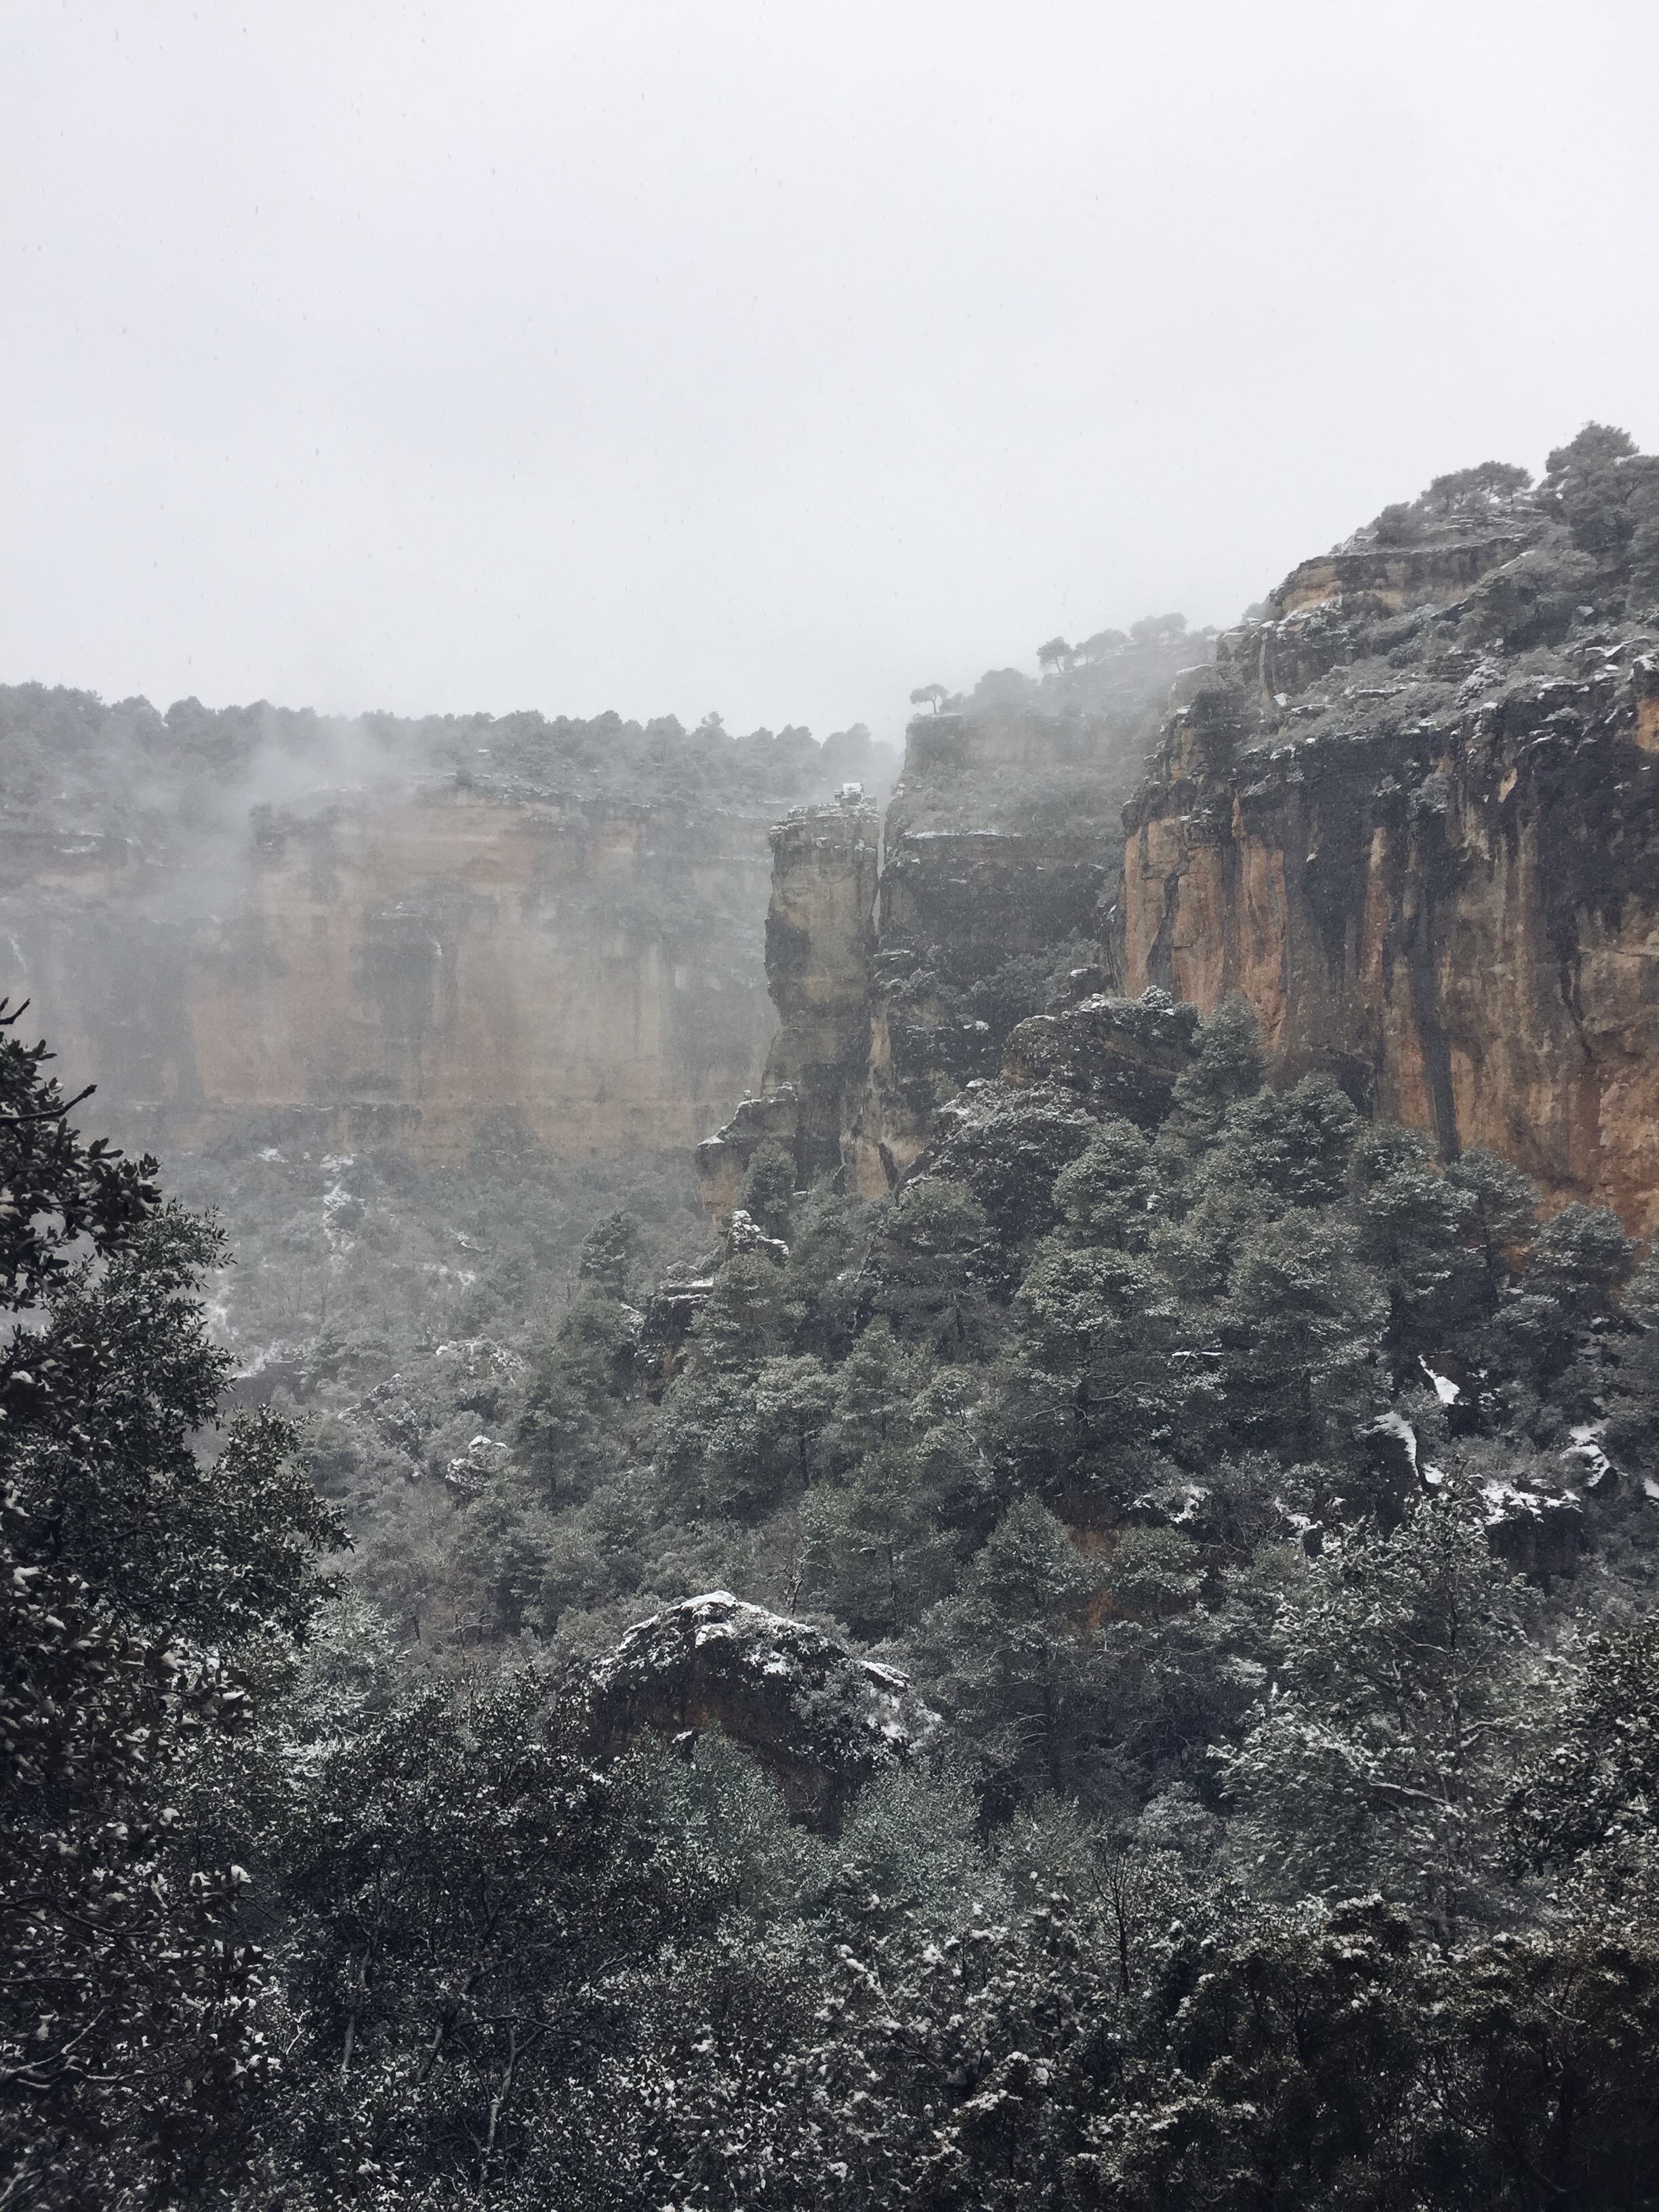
[279,1677,723,2201]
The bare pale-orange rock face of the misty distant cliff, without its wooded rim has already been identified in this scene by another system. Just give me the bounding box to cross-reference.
[5,792,772,1162]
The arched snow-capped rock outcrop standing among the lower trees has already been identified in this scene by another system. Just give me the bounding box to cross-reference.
[588,1591,933,1836]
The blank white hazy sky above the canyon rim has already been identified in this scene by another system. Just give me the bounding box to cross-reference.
[0,0,1659,737]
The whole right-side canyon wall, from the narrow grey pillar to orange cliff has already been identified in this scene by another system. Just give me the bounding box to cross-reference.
[703,427,1659,1237]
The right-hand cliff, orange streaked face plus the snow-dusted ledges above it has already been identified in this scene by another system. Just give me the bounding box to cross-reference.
[1117,482,1659,1237]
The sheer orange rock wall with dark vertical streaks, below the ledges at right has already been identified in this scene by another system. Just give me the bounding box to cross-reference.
[1117,665,1659,1237]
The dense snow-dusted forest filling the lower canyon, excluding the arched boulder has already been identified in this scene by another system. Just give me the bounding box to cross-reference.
[0,956,1659,2207]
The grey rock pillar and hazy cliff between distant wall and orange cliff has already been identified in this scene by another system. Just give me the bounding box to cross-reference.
[697,617,1210,1214]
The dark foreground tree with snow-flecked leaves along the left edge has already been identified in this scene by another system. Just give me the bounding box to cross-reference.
[0,1026,338,2212]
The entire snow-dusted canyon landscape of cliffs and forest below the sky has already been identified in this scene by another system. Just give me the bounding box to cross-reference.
[0,425,1659,2212]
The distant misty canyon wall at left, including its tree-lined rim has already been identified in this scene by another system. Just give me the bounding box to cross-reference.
[0,686,911,1164]
